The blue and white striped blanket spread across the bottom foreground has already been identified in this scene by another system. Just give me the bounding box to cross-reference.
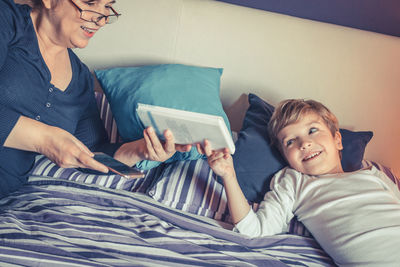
[0,176,333,266]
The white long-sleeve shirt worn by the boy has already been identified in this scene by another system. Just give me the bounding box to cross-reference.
[235,167,400,266]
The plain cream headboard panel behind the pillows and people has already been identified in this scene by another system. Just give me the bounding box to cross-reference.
[77,0,400,174]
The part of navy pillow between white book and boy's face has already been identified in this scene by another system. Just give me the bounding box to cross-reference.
[233,94,286,202]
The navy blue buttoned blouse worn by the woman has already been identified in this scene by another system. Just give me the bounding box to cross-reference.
[0,0,118,198]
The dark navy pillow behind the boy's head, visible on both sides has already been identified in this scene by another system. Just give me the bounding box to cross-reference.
[233,94,373,202]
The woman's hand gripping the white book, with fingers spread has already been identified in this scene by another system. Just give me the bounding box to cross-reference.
[114,127,192,166]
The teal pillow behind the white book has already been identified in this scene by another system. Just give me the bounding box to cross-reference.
[94,64,230,170]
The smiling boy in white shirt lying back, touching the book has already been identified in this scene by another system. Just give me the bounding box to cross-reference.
[199,99,400,266]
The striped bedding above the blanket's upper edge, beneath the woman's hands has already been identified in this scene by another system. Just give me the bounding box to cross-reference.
[32,156,311,237]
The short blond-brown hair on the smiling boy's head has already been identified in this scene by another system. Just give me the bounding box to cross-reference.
[268,99,339,151]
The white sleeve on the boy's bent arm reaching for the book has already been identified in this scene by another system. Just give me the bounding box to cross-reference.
[234,168,296,237]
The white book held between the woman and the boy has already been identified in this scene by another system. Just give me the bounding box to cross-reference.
[136,103,235,154]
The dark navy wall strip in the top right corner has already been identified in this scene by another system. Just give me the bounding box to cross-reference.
[219,0,400,37]
